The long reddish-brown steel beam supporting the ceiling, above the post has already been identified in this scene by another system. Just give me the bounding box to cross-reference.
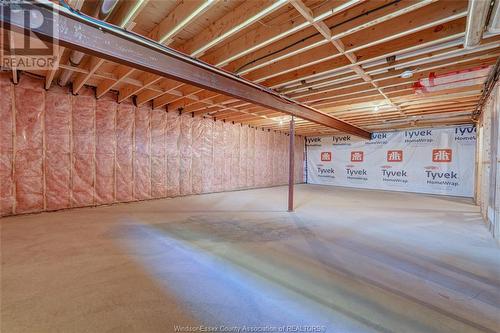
[1,3,370,138]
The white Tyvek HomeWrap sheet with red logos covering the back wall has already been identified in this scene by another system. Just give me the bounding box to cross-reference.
[306,125,476,197]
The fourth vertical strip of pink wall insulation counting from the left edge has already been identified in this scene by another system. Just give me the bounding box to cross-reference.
[72,89,96,207]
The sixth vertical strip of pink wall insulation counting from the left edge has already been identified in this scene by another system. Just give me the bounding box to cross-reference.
[115,102,135,202]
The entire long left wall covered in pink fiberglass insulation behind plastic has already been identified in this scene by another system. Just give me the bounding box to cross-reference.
[0,75,304,216]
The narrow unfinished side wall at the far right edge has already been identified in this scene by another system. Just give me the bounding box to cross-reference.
[475,83,500,242]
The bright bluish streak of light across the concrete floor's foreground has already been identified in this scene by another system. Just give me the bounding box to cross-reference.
[116,219,372,332]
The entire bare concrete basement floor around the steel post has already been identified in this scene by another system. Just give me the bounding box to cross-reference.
[1,185,500,333]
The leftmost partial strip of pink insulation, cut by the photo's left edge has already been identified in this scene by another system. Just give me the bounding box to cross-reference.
[0,74,15,216]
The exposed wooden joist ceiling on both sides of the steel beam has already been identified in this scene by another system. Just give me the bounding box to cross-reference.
[3,0,500,135]
